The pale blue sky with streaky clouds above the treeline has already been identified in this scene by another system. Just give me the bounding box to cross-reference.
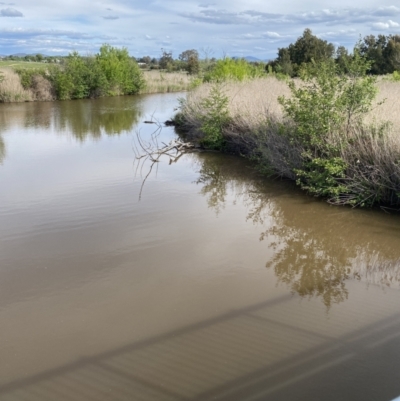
[0,0,400,60]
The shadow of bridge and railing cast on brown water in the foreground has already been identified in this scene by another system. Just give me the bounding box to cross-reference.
[0,291,400,401]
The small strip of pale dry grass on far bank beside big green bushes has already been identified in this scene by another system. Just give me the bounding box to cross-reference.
[140,70,193,94]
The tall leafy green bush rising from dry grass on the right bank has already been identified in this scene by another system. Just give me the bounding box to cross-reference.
[279,49,377,200]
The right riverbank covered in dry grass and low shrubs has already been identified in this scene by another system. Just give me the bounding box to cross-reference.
[175,77,400,209]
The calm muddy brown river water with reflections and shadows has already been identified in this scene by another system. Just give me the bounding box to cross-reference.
[0,94,400,401]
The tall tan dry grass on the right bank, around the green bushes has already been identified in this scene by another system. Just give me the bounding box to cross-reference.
[181,77,400,207]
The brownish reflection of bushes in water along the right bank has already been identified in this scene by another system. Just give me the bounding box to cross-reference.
[192,154,400,308]
